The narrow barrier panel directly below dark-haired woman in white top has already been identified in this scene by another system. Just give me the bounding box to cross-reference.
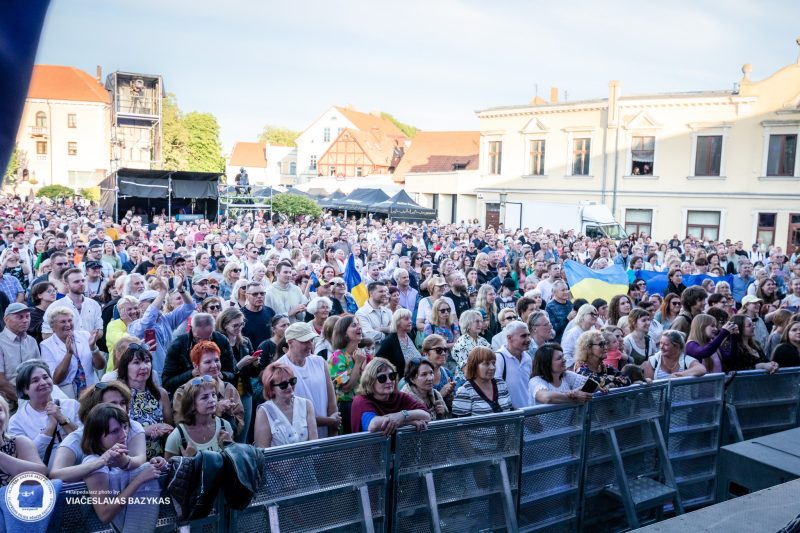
[519,404,587,532]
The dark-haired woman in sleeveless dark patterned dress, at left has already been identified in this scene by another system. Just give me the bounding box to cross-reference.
[117,343,174,459]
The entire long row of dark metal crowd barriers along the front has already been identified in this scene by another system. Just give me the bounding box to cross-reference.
[61,368,800,533]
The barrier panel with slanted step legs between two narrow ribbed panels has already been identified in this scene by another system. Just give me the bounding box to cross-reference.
[582,382,683,528]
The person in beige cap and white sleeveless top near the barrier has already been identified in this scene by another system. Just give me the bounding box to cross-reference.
[278,322,342,438]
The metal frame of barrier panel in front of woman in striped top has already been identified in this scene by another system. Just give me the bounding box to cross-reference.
[392,411,522,533]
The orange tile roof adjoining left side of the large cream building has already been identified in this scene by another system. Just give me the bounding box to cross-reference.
[392,131,481,183]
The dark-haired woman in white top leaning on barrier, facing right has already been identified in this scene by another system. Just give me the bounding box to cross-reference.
[528,342,592,405]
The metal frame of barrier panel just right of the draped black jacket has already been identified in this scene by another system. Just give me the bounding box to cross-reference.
[228,433,392,533]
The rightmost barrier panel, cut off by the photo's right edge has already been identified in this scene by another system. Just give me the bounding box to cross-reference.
[725,367,800,444]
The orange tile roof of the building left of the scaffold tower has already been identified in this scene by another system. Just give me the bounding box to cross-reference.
[28,65,111,104]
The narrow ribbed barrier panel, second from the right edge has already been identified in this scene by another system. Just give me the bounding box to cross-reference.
[666,374,725,507]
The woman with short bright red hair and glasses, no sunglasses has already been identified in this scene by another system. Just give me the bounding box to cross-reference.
[172,341,246,437]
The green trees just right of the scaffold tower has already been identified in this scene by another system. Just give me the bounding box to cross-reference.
[162,94,225,172]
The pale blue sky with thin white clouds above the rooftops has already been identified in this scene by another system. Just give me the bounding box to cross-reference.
[37,0,800,150]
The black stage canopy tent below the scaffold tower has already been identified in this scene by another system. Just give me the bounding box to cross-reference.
[100,168,222,220]
